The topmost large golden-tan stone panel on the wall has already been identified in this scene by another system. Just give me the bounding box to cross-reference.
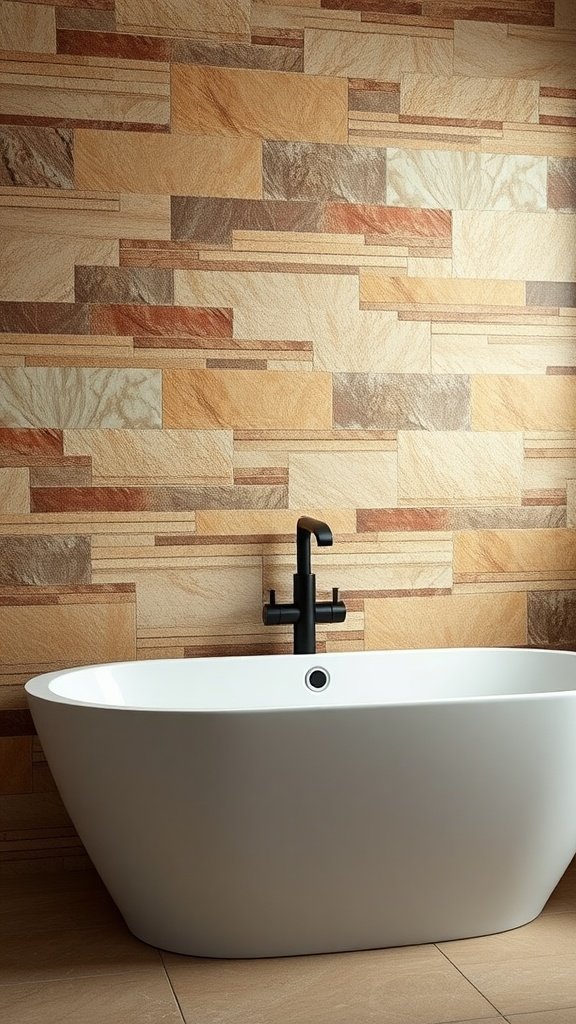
[74,130,261,197]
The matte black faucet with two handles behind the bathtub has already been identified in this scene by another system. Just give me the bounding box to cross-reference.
[262,516,346,654]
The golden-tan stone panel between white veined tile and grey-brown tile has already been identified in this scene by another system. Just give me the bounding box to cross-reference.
[163,370,332,430]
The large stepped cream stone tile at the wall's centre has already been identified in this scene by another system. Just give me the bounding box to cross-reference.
[174,270,429,373]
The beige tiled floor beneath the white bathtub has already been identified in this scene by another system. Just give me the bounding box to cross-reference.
[0,861,576,1024]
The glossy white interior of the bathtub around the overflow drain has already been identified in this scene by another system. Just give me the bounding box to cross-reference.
[27,648,576,713]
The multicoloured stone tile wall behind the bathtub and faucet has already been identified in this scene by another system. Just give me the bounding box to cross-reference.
[0,0,576,870]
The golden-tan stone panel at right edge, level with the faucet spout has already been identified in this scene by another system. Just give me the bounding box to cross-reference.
[454,529,576,574]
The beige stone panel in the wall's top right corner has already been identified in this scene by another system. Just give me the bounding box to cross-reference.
[454,20,576,89]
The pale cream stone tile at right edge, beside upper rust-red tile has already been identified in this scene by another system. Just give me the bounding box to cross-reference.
[452,210,576,281]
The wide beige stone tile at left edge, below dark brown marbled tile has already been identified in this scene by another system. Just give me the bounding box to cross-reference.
[0,190,170,241]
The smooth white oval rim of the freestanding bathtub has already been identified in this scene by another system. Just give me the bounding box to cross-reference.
[25,647,576,716]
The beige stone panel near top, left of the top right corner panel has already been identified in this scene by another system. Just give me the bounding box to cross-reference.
[304,29,452,82]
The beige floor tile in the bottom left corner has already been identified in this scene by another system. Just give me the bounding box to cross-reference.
[0,968,182,1024]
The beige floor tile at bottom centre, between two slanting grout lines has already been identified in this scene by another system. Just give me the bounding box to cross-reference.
[164,946,494,1024]
